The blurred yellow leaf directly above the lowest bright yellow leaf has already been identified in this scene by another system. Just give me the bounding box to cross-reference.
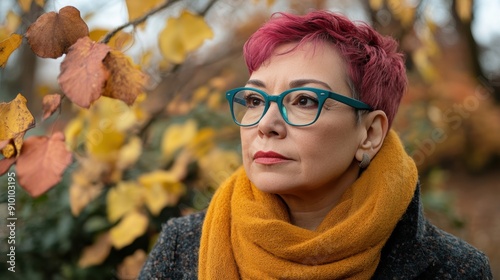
[106,182,143,223]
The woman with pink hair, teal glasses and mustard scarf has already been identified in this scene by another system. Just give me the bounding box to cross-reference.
[140,11,492,279]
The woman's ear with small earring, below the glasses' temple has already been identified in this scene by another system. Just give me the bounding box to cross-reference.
[356,110,389,161]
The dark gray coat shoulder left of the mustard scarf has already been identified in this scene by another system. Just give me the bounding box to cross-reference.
[139,211,205,279]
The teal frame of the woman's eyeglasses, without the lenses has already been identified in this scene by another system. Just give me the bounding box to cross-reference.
[226,87,373,127]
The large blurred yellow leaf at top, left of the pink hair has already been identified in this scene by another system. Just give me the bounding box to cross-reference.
[159,11,214,63]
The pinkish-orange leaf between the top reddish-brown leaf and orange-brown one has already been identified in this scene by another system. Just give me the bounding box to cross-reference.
[58,37,111,108]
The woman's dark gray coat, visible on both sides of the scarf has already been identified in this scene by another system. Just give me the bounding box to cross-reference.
[139,187,493,280]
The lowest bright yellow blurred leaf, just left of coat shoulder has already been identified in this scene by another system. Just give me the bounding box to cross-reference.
[110,211,149,250]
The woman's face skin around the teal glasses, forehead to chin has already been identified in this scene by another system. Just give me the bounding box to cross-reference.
[241,43,362,199]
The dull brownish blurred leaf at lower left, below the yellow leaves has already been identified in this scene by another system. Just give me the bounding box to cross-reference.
[78,232,111,268]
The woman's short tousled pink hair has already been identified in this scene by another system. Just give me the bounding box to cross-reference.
[243,11,408,126]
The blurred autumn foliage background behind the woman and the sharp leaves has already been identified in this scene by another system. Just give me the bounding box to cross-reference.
[0,0,500,279]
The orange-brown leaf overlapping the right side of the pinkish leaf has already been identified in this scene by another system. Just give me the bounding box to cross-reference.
[103,51,146,105]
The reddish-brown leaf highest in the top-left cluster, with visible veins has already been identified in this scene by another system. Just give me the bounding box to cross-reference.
[26,6,89,58]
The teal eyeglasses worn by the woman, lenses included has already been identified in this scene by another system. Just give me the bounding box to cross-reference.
[226,87,373,126]
